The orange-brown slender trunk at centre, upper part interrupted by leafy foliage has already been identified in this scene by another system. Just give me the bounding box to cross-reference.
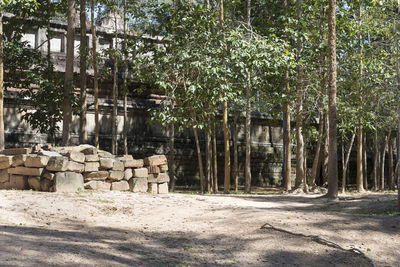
[219,0,231,194]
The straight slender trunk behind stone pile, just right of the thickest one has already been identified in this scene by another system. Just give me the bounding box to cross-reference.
[79,0,87,144]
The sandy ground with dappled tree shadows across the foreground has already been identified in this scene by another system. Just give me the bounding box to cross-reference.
[0,190,400,266]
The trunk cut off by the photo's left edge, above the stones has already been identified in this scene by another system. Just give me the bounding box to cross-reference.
[0,11,5,150]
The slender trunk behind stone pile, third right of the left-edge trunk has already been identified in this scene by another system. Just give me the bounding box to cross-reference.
[90,0,99,148]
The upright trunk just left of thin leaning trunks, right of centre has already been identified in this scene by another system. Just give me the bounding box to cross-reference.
[295,0,305,191]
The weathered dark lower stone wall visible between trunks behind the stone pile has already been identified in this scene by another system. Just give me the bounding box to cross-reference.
[4,98,294,186]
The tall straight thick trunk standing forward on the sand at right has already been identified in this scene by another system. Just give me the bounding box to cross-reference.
[327,0,338,199]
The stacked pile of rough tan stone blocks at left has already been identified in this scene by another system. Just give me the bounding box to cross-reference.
[0,145,169,194]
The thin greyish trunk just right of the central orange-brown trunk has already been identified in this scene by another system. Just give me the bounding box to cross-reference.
[244,0,251,193]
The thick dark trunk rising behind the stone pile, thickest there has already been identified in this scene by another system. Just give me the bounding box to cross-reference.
[62,0,75,146]
